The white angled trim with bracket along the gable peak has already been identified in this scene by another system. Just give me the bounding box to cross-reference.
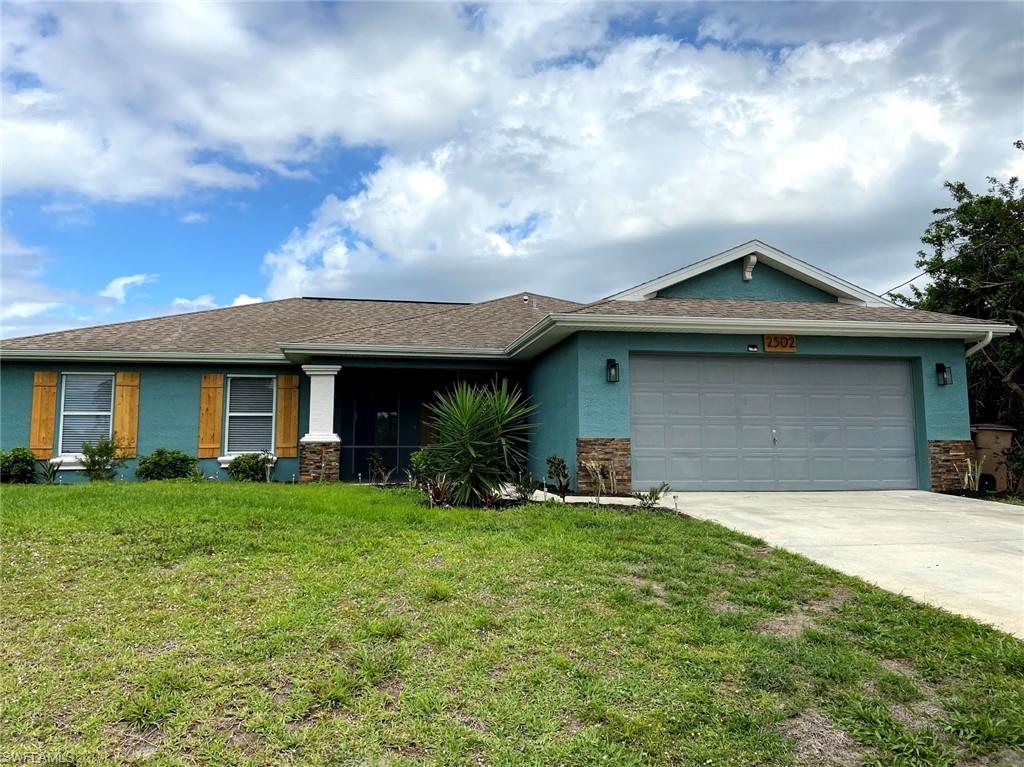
[608,240,896,306]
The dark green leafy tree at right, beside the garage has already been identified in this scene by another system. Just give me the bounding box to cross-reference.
[895,158,1024,487]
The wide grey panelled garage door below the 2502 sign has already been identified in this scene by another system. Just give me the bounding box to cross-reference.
[630,354,918,491]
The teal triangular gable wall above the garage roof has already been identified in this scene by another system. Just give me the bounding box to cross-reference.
[657,258,839,303]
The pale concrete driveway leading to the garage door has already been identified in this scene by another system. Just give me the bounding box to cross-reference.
[666,491,1024,638]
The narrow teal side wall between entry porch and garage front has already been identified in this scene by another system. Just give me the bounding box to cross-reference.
[526,336,580,481]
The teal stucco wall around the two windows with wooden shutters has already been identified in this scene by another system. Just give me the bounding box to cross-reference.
[0,363,309,482]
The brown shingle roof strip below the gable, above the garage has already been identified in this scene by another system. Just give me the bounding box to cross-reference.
[573,298,992,325]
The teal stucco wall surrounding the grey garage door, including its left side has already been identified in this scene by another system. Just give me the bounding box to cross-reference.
[529,333,971,488]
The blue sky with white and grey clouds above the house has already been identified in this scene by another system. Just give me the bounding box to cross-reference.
[0,1,1024,337]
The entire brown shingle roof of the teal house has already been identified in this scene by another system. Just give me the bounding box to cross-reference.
[0,293,991,359]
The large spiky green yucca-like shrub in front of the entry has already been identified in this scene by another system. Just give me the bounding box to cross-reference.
[428,380,535,506]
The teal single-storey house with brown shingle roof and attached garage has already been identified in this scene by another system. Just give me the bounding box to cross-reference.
[0,241,1014,491]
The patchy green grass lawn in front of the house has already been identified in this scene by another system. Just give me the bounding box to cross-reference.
[0,483,1024,767]
